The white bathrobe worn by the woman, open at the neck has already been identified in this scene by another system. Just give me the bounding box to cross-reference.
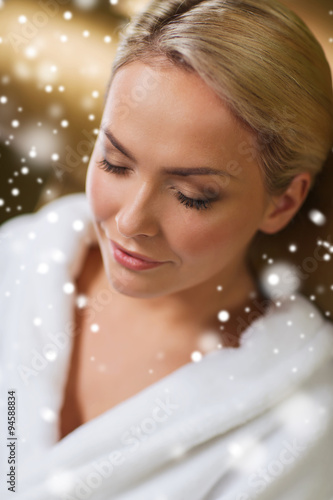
[0,193,333,500]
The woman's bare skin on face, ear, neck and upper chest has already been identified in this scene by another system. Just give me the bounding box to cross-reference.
[60,61,311,437]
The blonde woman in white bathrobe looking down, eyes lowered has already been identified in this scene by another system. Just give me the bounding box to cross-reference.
[1,0,333,500]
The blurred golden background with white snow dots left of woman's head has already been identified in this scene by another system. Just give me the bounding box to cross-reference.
[0,0,134,223]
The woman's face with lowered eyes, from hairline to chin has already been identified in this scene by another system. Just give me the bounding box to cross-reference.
[86,61,269,298]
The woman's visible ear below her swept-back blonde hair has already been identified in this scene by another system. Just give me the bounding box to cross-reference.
[258,172,312,234]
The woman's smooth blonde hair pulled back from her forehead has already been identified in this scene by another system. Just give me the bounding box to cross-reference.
[109,0,333,194]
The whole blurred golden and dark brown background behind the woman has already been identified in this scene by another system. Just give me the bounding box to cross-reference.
[0,0,333,317]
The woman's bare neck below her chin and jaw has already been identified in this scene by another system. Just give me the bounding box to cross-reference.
[95,242,270,347]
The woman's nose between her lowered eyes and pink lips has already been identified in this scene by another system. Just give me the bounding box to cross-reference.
[115,182,159,238]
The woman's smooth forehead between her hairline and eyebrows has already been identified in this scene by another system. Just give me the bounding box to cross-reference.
[103,61,255,176]
